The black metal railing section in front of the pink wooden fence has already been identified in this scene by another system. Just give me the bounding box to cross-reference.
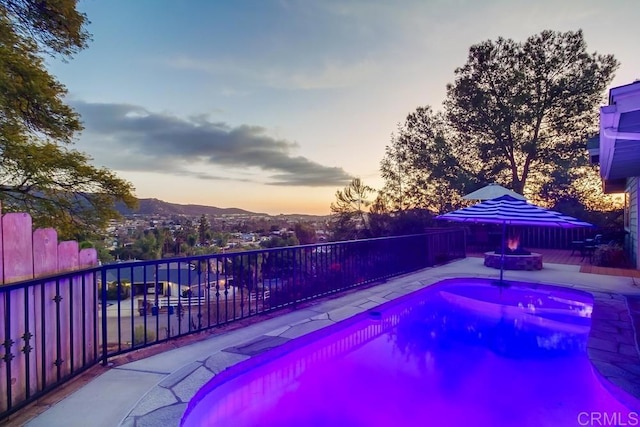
[0,268,102,420]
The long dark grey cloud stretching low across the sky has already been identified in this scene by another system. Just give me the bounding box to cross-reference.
[72,101,351,187]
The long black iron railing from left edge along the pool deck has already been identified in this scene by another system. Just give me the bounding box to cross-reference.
[0,229,465,420]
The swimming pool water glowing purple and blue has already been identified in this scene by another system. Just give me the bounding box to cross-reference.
[182,279,640,427]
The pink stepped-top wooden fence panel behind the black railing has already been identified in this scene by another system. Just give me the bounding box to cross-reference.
[0,206,98,413]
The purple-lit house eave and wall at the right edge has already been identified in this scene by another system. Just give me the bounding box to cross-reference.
[587,80,640,268]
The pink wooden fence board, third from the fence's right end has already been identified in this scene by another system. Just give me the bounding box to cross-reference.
[33,228,58,389]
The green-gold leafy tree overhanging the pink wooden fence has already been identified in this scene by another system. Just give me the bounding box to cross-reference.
[0,0,136,237]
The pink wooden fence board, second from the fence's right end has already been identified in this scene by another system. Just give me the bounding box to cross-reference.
[57,240,78,377]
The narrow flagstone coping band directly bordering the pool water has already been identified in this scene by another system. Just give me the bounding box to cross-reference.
[115,262,640,427]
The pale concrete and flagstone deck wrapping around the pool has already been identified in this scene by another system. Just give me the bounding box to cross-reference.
[18,258,640,427]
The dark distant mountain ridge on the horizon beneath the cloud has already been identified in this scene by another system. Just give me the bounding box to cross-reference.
[116,199,267,216]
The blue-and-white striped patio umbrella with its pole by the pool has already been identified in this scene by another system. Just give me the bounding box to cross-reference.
[436,195,593,282]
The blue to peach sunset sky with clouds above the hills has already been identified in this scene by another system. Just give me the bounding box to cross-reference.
[48,0,640,214]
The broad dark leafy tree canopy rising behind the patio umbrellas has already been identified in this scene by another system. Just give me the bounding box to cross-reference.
[381,31,618,212]
